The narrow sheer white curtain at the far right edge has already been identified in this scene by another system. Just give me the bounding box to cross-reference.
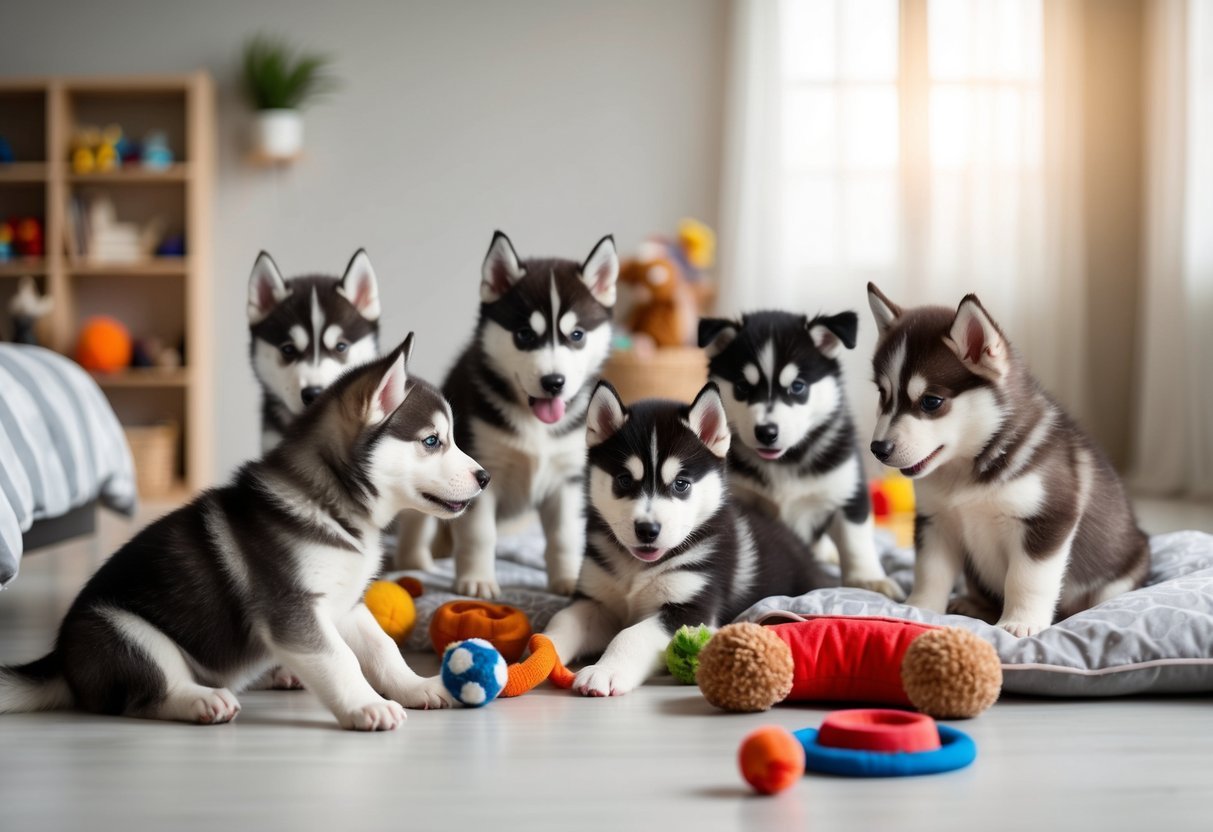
[1133,0,1213,497]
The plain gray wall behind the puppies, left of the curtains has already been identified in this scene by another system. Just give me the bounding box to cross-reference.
[0,0,727,477]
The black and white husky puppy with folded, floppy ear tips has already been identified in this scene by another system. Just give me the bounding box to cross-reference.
[699,312,904,600]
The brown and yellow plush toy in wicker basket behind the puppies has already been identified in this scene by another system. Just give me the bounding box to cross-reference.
[619,220,716,347]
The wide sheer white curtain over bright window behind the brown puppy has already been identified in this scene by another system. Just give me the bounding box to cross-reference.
[721,0,1084,434]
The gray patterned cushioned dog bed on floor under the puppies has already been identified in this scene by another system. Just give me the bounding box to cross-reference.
[394,529,1213,696]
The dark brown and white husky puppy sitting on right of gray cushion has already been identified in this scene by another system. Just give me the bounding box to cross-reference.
[867,284,1150,637]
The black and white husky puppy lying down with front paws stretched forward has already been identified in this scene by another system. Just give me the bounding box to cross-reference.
[546,382,814,696]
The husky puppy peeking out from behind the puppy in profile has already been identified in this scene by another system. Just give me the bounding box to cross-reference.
[249,249,380,454]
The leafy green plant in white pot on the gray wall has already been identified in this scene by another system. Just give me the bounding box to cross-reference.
[244,35,337,161]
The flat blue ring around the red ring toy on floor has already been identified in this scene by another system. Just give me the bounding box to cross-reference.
[792,725,978,777]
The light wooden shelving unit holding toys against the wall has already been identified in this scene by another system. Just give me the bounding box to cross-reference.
[0,73,215,494]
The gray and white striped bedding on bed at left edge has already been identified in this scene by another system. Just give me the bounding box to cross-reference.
[0,343,135,588]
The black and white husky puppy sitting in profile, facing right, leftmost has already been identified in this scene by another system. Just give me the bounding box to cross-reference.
[0,335,488,730]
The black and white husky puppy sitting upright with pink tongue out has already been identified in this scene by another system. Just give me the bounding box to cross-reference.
[395,232,619,598]
